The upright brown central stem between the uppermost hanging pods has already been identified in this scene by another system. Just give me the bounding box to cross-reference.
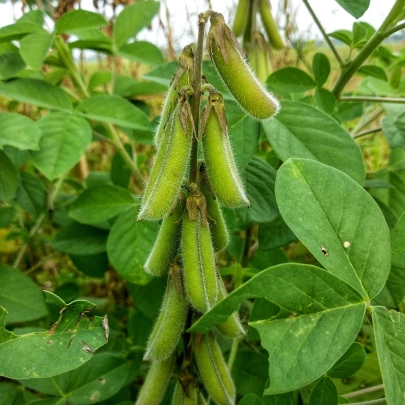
[189,13,207,183]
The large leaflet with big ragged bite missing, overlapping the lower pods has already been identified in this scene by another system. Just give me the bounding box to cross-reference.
[188,264,366,394]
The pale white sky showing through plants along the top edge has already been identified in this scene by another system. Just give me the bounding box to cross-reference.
[0,0,395,49]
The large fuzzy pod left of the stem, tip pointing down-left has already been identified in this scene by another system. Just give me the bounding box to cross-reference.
[138,94,193,221]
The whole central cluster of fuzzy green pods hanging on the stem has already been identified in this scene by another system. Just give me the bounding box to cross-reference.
[136,13,278,405]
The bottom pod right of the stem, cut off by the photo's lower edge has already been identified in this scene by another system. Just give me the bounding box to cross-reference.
[193,332,235,405]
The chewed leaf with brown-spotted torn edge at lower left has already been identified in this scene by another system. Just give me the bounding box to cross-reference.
[0,301,108,379]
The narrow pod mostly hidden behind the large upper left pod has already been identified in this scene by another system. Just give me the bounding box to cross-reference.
[154,45,194,149]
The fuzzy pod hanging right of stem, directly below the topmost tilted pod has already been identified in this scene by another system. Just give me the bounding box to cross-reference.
[201,93,250,208]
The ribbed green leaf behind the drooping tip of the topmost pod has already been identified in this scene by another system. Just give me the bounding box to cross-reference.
[262,101,365,185]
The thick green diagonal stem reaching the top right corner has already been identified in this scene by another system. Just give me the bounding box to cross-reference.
[332,0,405,99]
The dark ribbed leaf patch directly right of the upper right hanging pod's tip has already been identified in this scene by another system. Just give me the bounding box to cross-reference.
[238,156,279,223]
